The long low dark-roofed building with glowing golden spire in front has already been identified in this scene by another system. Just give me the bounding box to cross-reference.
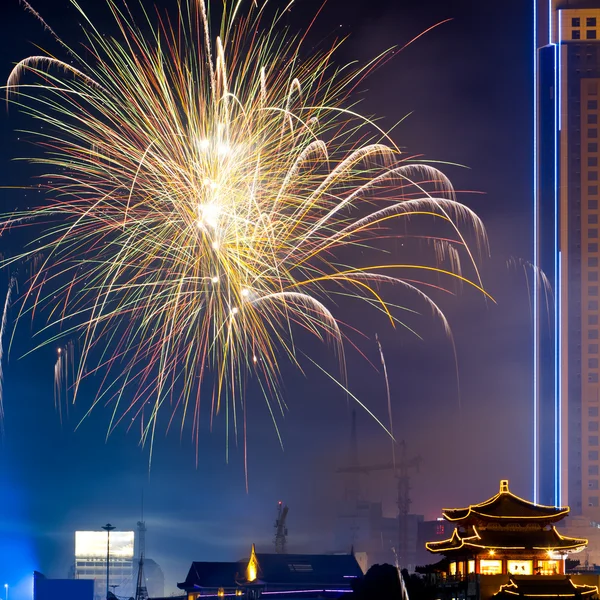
[177,545,363,600]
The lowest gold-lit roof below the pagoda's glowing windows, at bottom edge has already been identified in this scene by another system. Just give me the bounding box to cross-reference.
[494,575,598,598]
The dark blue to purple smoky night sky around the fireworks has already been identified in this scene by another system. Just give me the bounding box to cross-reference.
[0,0,532,600]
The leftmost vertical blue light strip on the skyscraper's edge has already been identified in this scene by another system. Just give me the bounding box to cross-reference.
[533,0,539,502]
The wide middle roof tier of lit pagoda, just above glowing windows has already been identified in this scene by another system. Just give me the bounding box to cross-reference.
[425,526,588,553]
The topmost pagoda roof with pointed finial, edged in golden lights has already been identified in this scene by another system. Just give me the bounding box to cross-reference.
[442,479,569,522]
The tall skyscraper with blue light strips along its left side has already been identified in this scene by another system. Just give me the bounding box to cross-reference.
[534,0,600,523]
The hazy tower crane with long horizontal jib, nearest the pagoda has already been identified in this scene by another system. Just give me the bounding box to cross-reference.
[337,441,421,567]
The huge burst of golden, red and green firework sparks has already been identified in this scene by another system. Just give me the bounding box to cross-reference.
[3,0,485,460]
